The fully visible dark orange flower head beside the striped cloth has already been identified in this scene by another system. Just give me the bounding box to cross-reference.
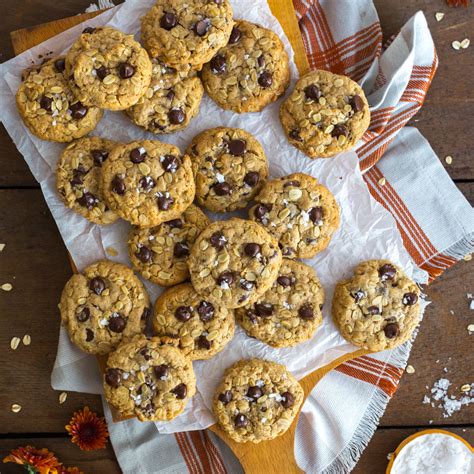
[66,407,109,451]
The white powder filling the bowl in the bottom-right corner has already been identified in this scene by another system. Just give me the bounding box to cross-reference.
[390,433,474,474]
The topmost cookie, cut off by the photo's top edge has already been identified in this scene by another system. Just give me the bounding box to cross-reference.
[141,0,234,69]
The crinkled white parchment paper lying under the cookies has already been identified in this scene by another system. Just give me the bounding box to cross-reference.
[0,0,426,432]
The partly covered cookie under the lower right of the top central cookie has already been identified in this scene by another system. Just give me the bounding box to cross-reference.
[235,258,324,347]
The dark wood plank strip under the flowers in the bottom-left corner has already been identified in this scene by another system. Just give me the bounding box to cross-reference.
[0,438,122,474]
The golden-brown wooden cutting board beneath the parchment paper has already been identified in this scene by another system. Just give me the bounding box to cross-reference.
[10,4,368,474]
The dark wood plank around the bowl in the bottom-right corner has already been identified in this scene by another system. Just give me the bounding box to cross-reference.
[352,427,474,474]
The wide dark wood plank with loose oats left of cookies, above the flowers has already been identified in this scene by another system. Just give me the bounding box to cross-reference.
[0,189,102,433]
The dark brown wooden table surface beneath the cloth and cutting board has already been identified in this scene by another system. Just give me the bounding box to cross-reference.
[0,0,474,474]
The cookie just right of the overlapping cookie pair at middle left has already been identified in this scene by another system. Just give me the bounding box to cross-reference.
[186,127,268,212]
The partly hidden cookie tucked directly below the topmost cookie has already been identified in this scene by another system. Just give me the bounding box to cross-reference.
[126,59,204,133]
